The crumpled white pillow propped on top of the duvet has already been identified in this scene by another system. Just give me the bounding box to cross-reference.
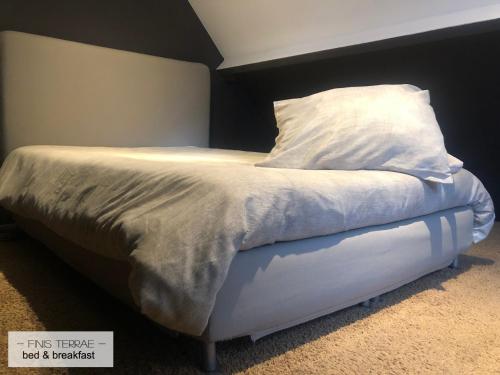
[256,85,453,183]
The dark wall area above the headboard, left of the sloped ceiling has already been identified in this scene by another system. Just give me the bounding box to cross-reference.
[0,0,222,68]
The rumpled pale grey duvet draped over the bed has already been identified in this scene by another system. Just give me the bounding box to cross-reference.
[0,146,494,335]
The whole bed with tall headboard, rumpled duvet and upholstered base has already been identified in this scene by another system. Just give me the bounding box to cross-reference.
[0,33,494,370]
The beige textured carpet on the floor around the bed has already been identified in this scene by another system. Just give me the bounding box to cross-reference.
[0,225,500,374]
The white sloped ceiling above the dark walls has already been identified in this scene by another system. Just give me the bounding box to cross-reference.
[189,0,500,68]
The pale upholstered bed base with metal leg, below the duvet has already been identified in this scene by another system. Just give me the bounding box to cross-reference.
[12,207,473,372]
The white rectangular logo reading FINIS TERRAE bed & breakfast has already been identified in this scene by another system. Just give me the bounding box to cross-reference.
[9,331,113,367]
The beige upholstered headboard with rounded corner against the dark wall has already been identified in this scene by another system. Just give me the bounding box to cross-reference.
[0,31,210,154]
